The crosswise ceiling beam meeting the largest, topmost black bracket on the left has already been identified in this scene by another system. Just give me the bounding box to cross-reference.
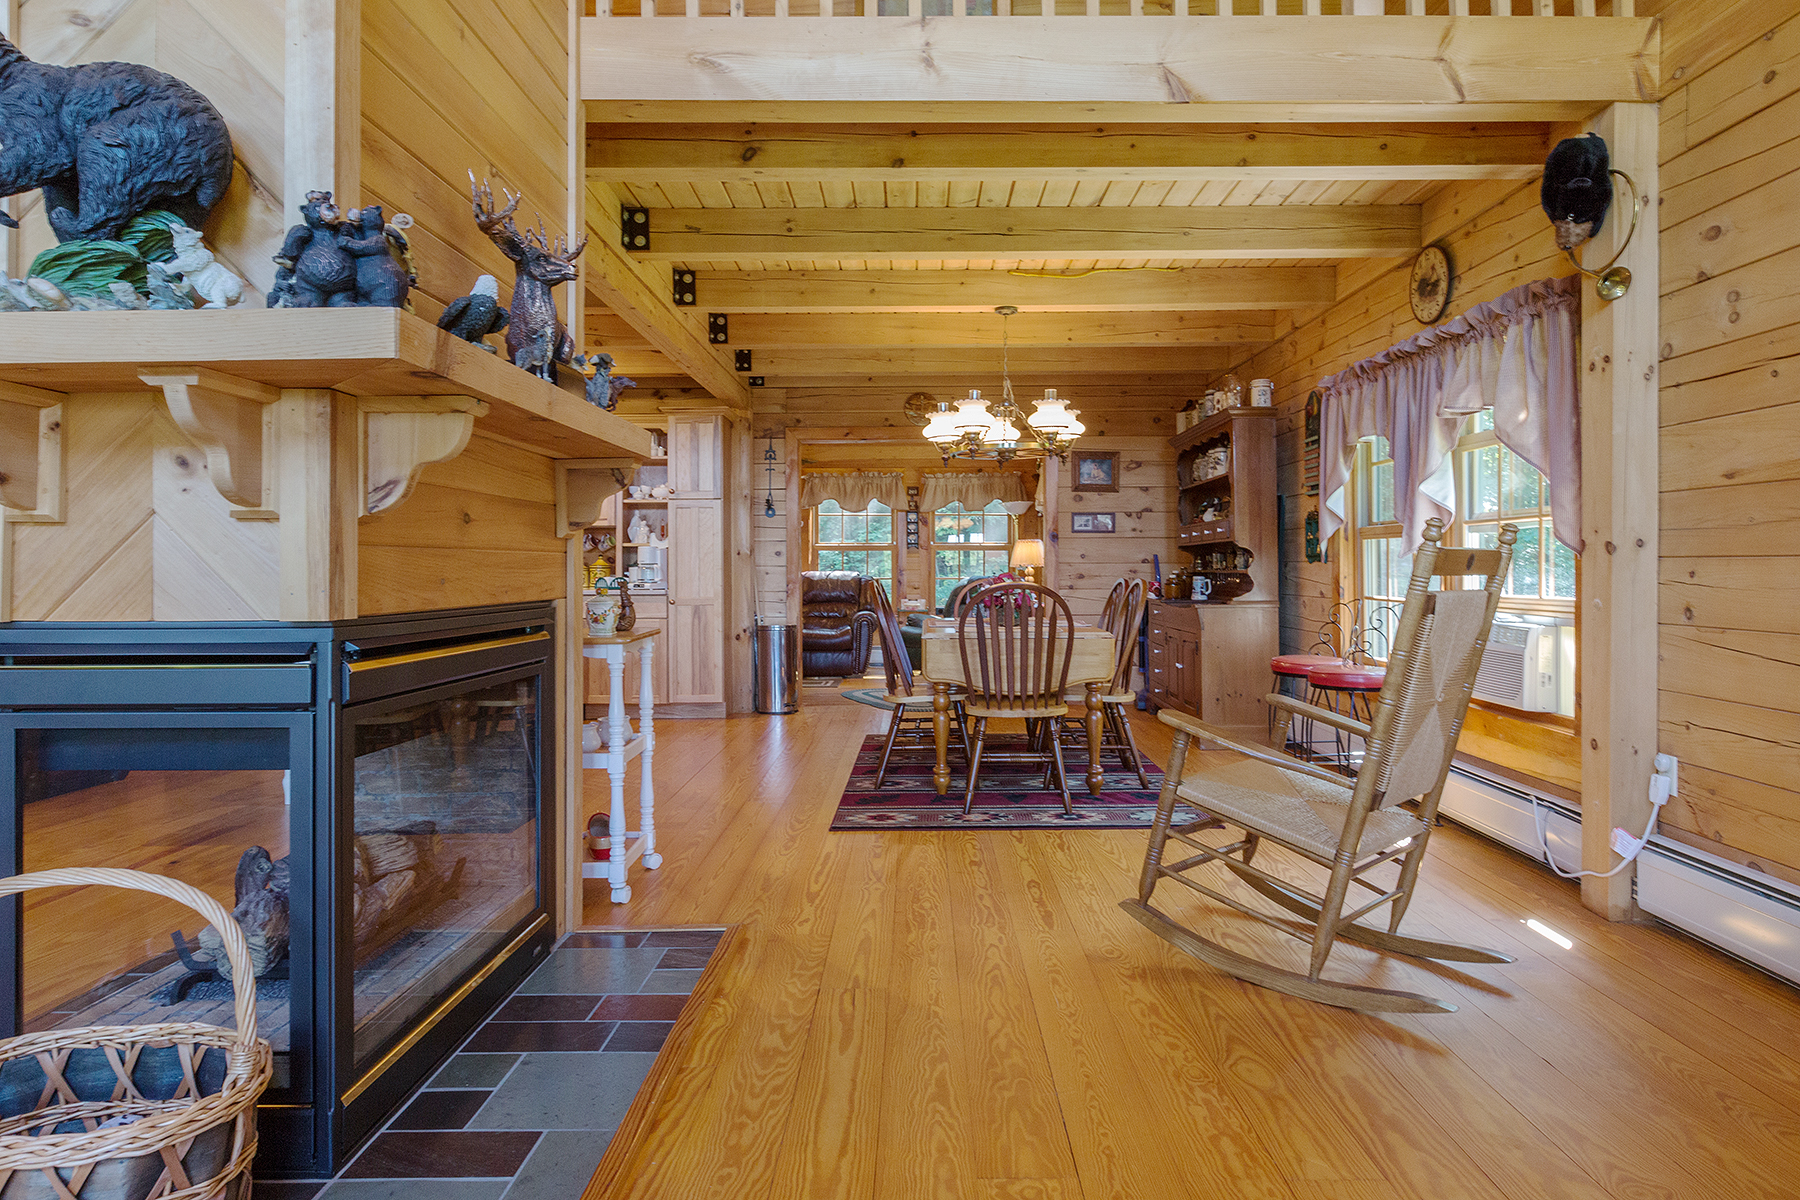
[632,205,1420,263]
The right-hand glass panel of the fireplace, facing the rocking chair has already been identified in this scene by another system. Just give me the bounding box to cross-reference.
[340,667,544,1076]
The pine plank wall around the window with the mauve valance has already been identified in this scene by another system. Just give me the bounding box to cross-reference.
[1235,180,1580,790]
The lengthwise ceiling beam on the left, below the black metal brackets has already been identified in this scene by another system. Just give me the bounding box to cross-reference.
[581,184,751,410]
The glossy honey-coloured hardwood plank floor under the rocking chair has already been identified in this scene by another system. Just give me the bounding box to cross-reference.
[585,703,1800,1200]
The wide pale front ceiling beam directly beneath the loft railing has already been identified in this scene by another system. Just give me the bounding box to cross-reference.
[580,16,1660,106]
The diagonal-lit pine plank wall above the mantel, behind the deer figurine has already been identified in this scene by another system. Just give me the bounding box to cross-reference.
[362,0,572,320]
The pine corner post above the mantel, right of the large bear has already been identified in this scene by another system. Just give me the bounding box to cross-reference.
[281,0,362,213]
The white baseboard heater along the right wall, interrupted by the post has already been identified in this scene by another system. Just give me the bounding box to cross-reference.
[1438,765,1800,982]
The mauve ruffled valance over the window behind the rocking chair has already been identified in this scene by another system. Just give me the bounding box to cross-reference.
[1319,275,1582,554]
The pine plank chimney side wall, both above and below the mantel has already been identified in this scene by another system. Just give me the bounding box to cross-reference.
[358,0,571,615]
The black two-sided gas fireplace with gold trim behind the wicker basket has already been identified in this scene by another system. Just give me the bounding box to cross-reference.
[0,604,556,1175]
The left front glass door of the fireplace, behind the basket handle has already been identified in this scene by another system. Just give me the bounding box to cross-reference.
[9,714,311,1092]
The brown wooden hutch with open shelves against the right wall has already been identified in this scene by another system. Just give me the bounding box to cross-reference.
[1145,408,1280,732]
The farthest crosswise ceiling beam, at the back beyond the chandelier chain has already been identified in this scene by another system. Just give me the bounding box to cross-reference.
[589,342,1242,377]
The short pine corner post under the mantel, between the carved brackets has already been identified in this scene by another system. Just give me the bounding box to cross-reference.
[274,389,364,621]
